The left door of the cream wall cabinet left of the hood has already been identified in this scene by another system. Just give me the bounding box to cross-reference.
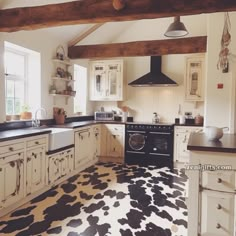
[91,63,106,100]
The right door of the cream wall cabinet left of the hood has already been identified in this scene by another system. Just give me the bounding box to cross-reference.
[106,62,122,100]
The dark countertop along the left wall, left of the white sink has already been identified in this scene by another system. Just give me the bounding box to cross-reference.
[0,128,51,142]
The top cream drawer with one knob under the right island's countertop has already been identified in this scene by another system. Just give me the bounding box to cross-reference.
[202,171,235,192]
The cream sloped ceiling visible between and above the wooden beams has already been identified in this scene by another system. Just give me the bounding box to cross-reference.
[0,0,206,45]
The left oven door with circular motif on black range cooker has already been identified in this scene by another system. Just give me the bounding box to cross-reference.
[126,131,147,154]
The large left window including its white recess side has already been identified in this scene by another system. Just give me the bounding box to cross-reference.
[4,42,41,119]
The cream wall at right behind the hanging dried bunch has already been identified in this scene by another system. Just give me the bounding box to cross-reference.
[205,12,236,133]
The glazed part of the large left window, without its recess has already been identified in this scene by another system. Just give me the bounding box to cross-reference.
[5,47,28,115]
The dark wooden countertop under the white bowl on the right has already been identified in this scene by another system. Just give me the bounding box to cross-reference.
[187,133,236,153]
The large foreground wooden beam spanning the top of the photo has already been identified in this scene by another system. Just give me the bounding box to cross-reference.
[0,0,236,32]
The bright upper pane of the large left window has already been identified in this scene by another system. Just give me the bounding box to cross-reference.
[5,51,25,77]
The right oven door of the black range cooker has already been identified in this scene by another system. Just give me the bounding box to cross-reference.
[148,132,173,158]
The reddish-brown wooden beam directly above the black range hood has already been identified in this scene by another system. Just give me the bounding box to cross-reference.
[68,36,207,59]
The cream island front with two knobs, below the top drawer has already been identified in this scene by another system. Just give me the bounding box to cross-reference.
[201,190,234,236]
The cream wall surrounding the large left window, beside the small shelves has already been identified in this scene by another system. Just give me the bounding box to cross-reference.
[0,30,73,122]
